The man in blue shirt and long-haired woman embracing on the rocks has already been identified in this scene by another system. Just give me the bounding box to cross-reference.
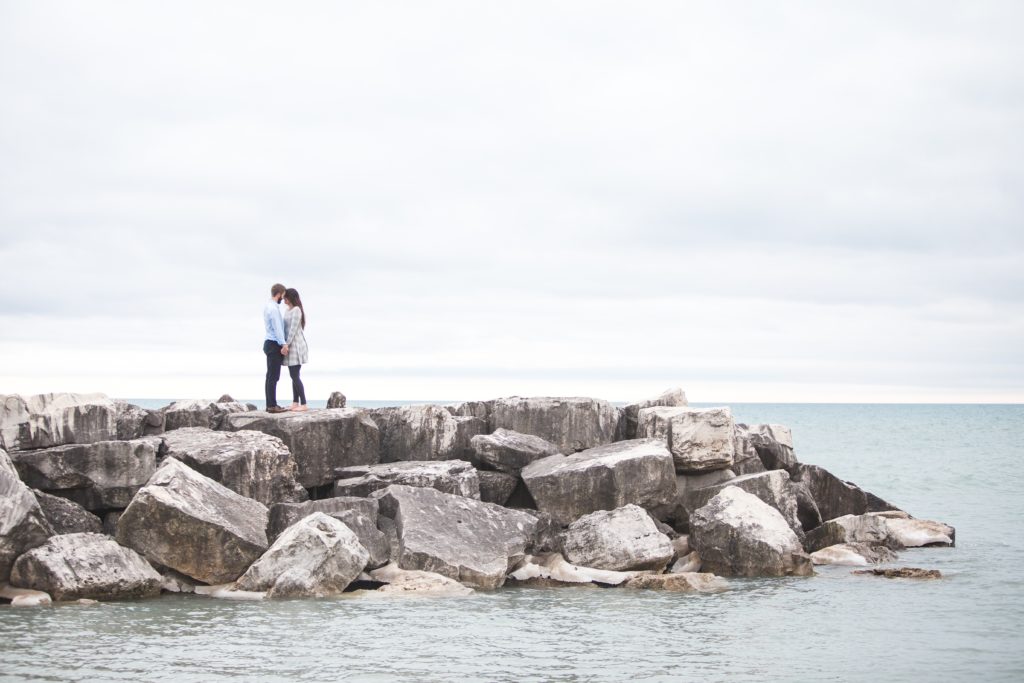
[263,285,309,413]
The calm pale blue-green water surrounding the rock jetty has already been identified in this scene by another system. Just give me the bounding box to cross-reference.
[0,401,1024,681]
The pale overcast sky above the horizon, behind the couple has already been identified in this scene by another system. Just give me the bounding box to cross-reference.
[0,0,1024,402]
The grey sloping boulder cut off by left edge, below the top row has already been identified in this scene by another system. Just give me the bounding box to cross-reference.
[0,451,53,585]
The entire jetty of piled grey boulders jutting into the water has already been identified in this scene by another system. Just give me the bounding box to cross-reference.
[0,389,955,606]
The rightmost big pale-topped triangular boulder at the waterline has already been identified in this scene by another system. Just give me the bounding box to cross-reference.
[689,486,814,577]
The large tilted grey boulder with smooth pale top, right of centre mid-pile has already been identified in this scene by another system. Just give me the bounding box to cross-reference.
[521,439,676,524]
